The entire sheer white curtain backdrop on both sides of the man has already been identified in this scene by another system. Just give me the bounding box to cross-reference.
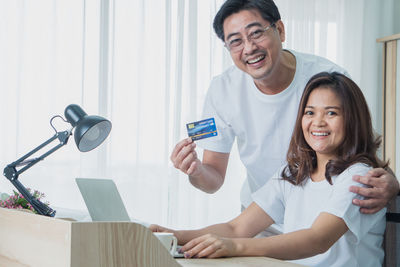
[0,0,395,230]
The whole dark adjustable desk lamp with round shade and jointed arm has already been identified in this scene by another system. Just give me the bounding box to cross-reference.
[3,104,111,217]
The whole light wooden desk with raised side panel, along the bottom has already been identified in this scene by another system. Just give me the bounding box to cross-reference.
[0,208,304,267]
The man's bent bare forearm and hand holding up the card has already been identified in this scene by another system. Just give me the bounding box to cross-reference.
[171,138,229,193]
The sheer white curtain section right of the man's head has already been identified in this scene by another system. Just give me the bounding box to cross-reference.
[275,0,400,132]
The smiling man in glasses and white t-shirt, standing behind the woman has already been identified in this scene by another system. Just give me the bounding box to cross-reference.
[171,0,399,222]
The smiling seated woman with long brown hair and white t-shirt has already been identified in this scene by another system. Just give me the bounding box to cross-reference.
[150,72,387,266]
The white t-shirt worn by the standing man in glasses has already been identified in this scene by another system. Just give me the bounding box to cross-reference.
[198,51,345,207]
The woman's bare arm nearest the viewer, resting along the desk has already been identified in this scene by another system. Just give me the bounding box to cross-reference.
[182,213,348,260]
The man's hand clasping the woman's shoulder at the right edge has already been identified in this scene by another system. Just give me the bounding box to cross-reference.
[350,168,399,214]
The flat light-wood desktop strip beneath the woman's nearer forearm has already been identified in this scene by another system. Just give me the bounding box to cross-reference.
[177,257,301,267]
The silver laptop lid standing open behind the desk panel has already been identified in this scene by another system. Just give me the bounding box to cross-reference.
[75,178,130,222]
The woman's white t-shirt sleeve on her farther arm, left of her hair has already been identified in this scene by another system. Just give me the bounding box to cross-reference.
[252,168,291,224]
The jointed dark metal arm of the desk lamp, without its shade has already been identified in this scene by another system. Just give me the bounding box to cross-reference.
[3,130,71,217]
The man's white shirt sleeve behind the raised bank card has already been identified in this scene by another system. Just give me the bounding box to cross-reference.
[196,77,235,153]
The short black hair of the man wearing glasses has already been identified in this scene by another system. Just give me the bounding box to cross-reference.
[213,0,281,41]
